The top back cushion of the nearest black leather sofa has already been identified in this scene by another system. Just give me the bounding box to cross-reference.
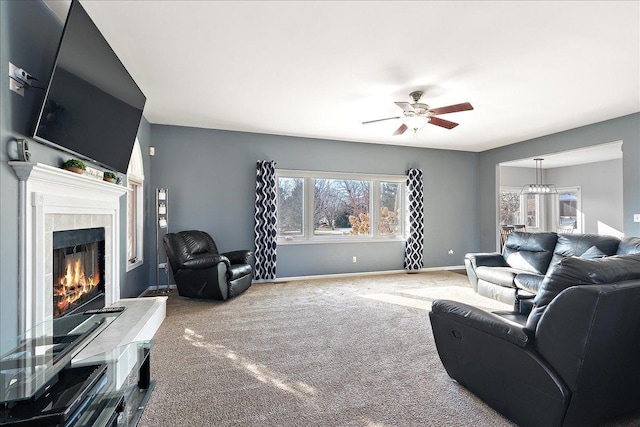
[527,254,640,331]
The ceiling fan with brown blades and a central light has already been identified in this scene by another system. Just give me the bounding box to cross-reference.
[362,90,473,135]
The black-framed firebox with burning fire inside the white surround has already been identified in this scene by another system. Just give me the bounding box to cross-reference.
[53,228,104,318]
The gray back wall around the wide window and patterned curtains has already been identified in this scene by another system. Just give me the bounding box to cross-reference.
[151,125,478,277]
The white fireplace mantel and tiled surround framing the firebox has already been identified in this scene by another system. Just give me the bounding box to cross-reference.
[9,162,127,334]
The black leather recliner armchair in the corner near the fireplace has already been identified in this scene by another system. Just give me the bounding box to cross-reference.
[162,230,253,301]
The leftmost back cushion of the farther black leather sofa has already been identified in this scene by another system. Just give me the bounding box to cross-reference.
[502,231,557,274]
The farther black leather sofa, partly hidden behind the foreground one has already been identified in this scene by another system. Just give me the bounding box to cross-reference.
[464,231,640,312]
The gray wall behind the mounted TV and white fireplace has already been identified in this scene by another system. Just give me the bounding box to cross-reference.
[0,1,150,353]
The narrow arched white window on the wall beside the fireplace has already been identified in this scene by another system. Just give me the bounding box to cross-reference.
[127,138,144,271]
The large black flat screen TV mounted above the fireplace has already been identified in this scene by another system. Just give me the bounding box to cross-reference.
[33,0,146,173]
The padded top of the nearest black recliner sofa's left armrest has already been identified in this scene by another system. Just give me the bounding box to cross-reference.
[431,300,529,347]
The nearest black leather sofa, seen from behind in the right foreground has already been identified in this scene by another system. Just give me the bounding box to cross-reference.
[430,254,640,427]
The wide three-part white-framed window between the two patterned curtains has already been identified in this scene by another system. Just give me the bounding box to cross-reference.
[276,170,406,242]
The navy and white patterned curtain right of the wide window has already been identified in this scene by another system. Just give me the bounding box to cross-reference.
[404,169,424,271]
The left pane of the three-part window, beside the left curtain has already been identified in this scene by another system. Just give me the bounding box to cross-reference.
[278,178,304,238]
